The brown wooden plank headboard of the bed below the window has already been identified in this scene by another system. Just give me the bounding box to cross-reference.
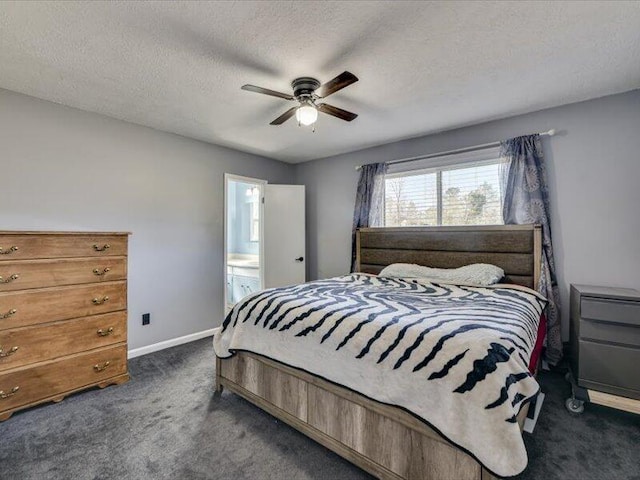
[356,225,542,288]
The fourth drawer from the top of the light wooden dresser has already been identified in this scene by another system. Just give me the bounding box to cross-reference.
[0,311,127,372]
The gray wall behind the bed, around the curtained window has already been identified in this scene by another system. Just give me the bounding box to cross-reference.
[296,90,640,338]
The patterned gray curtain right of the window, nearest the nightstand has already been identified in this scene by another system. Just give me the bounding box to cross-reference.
[500,135,562,365]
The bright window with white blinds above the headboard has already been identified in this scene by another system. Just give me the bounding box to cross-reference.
[385,150,503,227]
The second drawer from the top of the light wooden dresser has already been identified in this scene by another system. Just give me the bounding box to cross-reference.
[0,257,127,292]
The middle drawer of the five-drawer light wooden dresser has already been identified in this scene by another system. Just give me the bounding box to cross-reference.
[0,281,127,330]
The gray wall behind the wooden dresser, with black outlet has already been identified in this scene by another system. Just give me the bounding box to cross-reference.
[0,90,294,348]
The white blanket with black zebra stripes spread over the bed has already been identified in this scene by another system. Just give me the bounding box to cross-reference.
[214,274,546,476]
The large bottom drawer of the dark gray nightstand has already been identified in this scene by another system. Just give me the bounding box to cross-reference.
[578,340,640,393]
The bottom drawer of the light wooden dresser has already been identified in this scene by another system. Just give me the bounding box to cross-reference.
[0,346,127,412]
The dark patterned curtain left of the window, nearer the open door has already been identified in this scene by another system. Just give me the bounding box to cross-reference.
[351,163,387,272]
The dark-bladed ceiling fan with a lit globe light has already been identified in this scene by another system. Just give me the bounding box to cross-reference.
[242,72,358,125]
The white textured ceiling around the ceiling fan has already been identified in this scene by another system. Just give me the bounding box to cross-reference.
[0,1,640,162]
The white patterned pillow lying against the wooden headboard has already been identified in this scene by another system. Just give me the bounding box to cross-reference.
[378,263,504,285]
